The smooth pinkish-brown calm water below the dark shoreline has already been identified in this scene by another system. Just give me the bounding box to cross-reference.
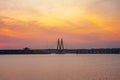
[0,54,120,80]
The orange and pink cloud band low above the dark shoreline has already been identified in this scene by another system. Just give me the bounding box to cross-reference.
[0,14,119,48]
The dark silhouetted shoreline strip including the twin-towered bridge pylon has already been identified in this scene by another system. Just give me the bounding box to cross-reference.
[0,38,120,54]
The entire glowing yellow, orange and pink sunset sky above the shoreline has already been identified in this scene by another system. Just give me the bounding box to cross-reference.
[0,0,120,49]
